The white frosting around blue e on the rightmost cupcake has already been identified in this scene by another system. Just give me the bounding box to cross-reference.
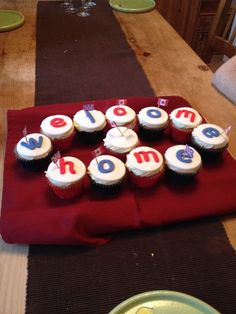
[192,123,229,149]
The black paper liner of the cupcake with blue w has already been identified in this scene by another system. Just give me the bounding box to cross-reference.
[14,149,52,172]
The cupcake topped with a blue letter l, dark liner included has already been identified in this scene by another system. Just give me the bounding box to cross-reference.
[73,110,106,142]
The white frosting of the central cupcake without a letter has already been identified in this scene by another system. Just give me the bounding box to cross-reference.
[103,126,138,154]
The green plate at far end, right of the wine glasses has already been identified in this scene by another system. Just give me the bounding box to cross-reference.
[109,0,156,13]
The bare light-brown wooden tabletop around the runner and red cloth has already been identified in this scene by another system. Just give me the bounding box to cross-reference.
[0,0,236,314]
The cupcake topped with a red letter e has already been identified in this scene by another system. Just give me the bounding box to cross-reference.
[40,114,75,151]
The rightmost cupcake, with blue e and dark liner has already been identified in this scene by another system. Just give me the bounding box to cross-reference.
[192,123,229,161]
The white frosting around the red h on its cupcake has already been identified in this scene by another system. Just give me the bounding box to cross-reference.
[45,156,86,187]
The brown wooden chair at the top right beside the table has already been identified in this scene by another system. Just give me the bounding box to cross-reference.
[202,0,236,64]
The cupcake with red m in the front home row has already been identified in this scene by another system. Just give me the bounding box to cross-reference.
[126,146,164,188]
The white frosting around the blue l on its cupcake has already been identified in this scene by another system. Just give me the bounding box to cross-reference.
[73,110,106,132]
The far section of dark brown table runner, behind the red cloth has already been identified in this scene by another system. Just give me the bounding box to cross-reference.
[35,0,153,105]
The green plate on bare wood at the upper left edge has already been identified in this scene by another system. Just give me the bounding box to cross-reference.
[0,10,25,32]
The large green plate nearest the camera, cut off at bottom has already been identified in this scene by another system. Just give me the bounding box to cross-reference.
[109,290,220,314]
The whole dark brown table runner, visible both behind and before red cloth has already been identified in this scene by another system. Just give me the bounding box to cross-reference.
[26,0,236,314]
